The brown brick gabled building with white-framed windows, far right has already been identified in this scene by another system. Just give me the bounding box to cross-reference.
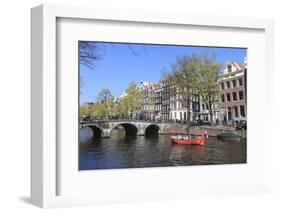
[219,61,247,122]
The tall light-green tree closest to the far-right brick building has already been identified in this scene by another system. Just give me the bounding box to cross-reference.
[196,54,221,125]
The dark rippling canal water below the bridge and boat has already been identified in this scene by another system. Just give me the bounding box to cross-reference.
[79,128,246,170]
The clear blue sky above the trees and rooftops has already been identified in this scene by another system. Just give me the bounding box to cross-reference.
[80,42,247,104]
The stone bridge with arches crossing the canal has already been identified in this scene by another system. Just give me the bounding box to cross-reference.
[80,120,187,138]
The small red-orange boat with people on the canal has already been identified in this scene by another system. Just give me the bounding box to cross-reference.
[170,131,208,146]
